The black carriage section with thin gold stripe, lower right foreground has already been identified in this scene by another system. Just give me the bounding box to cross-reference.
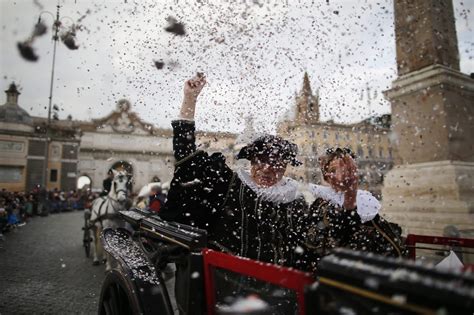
[306,249,474,315]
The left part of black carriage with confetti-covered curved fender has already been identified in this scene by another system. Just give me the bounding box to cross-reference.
[99,209,206,315]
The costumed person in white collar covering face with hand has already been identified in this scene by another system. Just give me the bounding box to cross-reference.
[299,148,405,271]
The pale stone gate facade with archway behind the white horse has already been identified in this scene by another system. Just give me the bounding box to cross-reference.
[78,99,235,191]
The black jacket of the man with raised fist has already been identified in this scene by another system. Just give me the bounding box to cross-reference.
[160,120,307,266]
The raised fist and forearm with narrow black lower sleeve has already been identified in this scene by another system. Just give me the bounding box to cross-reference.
[172,73,206,162]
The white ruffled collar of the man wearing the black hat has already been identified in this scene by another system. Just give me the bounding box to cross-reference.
[236,169,299,203]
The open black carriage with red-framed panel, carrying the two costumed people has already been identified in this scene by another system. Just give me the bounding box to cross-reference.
[99,209,474,314]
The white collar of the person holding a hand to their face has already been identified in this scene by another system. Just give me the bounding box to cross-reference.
[309,184,382,223]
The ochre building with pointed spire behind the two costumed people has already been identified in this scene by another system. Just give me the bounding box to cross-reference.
[278,73,393,197]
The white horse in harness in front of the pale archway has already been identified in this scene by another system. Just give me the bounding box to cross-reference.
[90,170,130,270]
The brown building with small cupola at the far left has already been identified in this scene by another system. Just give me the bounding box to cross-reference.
[0,83,80,191]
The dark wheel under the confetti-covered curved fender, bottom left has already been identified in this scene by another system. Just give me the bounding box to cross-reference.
[99,270,143,315]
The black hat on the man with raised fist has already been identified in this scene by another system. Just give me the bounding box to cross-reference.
[237,135,302,166]
